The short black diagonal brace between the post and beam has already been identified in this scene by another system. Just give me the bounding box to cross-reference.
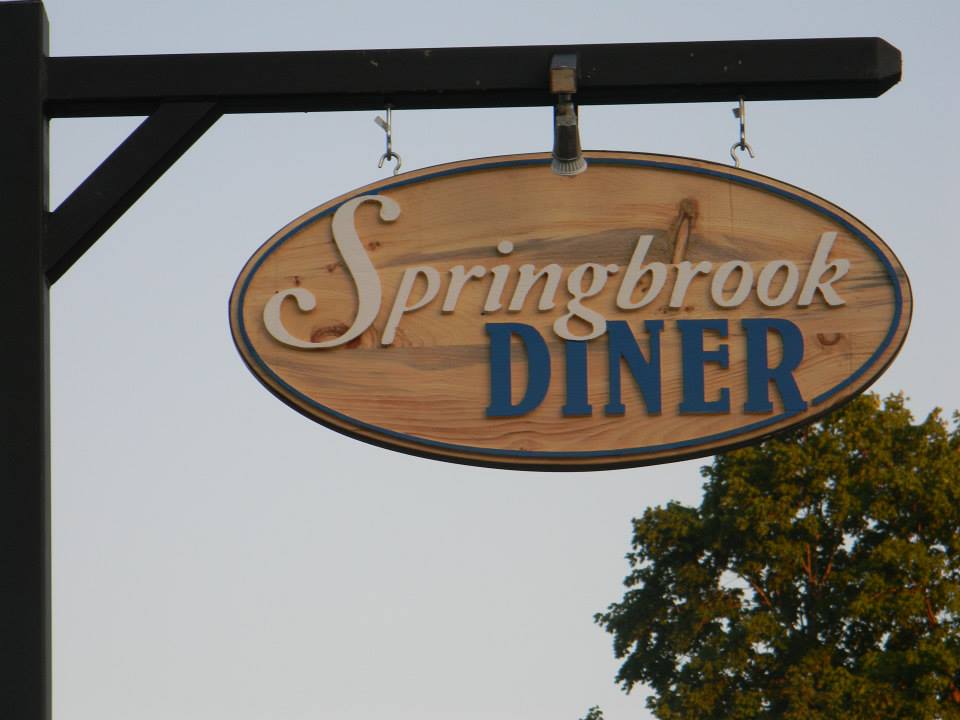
[43,102,221,284]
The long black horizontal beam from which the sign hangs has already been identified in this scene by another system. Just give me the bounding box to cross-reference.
[47,38,900,117]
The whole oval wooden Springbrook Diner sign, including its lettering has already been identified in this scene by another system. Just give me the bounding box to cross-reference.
[230,152,912,470]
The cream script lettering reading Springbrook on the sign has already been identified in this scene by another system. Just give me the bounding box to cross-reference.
[263,195,850,350]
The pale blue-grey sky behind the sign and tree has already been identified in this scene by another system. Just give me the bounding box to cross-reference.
[39,0,960,720]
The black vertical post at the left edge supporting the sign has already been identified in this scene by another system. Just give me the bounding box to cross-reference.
[0,2,50,720]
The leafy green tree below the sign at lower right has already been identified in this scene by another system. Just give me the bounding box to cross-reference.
[596,396,960,720]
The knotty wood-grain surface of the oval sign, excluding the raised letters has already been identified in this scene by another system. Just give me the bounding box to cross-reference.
[230,152,912,469]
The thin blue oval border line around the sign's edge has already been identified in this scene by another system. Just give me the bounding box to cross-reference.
[236,154,906,469]
